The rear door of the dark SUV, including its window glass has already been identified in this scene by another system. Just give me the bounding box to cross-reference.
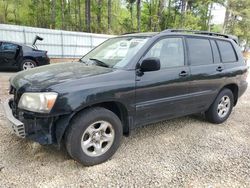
[186,37,224,113]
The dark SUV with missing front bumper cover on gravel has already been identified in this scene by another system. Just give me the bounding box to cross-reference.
[4,30,247,165]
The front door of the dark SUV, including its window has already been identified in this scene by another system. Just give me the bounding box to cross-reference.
[136,37,190,125]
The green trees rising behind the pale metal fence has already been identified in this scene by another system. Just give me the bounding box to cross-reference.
[0,0,250,47]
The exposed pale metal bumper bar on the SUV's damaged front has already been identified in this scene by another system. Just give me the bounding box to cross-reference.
[3,101,26,138]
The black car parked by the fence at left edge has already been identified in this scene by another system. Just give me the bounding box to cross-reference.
[0,36,50,70]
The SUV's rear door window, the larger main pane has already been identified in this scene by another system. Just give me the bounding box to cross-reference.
[187,38,213,65]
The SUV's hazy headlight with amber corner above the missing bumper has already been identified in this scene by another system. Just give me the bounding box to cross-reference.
[18,92,57,113]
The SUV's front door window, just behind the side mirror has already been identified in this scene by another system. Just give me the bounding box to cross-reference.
[145,38,184,68]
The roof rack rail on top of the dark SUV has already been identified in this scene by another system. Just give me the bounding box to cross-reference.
[162,29,239,44]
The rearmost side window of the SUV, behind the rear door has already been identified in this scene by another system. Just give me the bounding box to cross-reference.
[217,40,237,63]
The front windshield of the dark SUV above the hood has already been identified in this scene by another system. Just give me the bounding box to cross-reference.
[81,37,149,68]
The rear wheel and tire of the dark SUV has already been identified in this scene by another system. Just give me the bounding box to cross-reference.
[205,89,234,124]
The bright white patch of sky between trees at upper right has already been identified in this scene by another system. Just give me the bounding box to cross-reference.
[211,3,226,24]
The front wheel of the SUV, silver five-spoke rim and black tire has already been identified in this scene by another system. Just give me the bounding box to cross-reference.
[65,107,123,166]
